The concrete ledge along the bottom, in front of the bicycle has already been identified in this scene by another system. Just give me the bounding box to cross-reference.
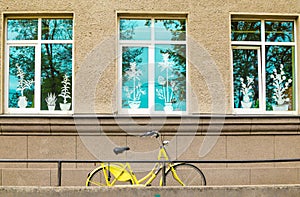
[0,184,300,197]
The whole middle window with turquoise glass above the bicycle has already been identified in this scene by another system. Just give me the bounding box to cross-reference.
[119,17,187,114]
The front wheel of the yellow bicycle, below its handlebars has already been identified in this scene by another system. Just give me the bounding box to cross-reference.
[166,163,206,186]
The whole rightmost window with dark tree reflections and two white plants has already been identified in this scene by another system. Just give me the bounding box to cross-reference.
[231,18,297,113]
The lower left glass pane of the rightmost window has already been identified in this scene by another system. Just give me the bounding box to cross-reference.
[232,49,259,108]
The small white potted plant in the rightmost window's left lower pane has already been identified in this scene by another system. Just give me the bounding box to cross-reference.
[240,76,254,108]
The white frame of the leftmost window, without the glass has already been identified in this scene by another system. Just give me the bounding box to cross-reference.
[4,15,75,115]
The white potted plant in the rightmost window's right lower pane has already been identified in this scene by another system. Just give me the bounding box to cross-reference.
[270,64,292,111]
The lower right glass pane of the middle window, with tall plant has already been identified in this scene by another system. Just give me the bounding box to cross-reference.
[154,45,186,111]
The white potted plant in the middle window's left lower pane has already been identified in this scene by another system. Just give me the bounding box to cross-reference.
[124,62,146,109]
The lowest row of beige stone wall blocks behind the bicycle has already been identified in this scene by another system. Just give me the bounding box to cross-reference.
[0,167,300,186]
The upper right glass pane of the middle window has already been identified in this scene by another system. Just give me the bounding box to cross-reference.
[155,19,186,40]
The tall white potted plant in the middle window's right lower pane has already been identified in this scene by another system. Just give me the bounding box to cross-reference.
[155,53,176,112]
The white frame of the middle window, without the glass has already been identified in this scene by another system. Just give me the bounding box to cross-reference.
[117,15,189,115]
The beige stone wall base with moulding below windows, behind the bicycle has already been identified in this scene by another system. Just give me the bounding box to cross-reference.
[0,117,300,186]
